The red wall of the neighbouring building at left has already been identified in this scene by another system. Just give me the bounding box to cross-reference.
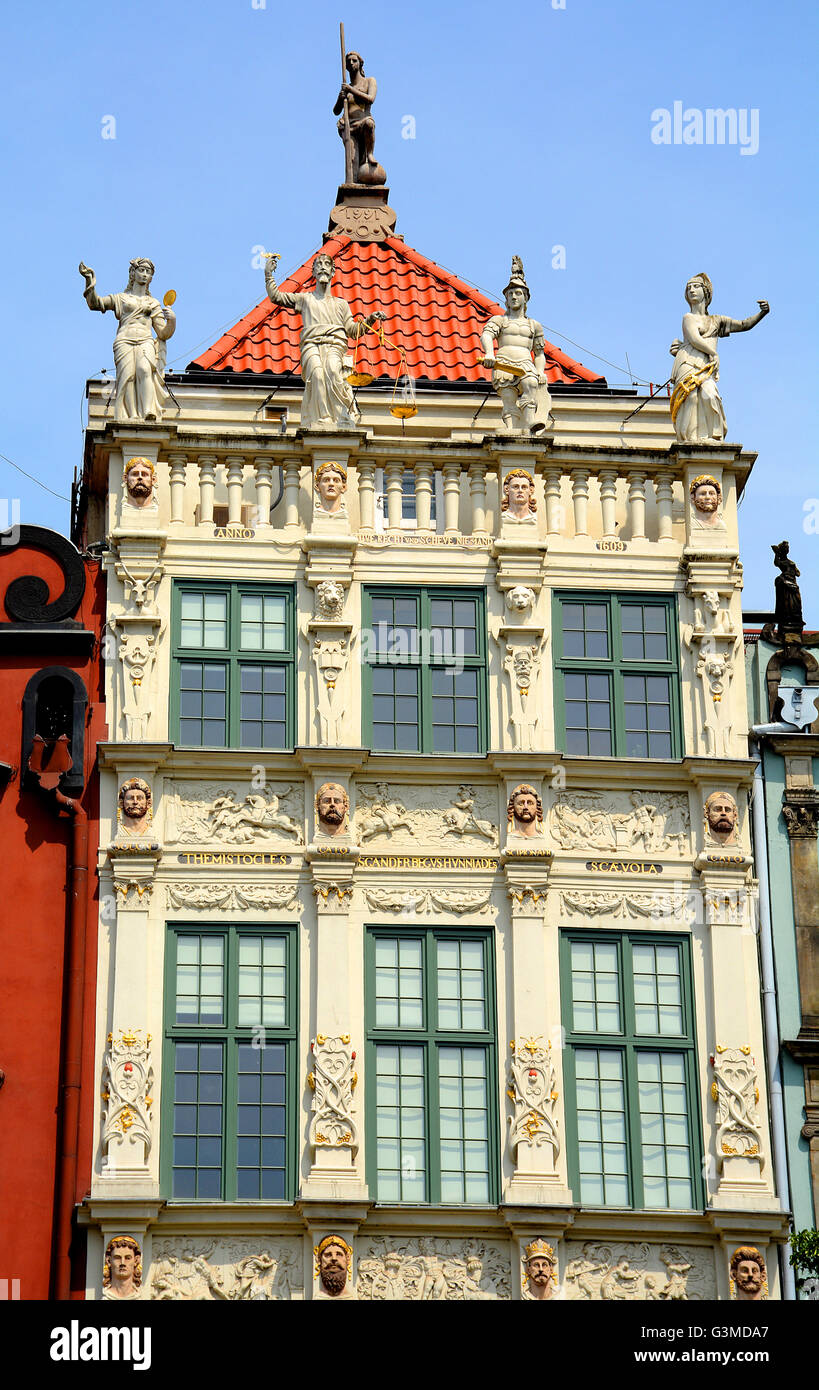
[0,532,106,1300]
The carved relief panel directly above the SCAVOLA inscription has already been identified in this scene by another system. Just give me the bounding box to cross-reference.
[548,791,691,855]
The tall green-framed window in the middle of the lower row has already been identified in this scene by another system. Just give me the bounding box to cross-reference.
[366,927,498,1205]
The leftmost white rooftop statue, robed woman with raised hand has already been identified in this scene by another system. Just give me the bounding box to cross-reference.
[79,256,177,420]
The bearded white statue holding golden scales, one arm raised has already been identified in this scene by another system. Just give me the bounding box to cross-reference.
[264,252,387,430]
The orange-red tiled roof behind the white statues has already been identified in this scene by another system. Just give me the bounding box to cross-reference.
[190,236,605,385]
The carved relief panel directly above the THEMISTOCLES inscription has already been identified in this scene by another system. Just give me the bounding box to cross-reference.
[165,783,303,845]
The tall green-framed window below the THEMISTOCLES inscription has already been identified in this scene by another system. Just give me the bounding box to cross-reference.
[161,924,298,1201]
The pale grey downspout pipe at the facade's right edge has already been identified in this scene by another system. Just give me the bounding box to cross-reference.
[751,724,797,1302]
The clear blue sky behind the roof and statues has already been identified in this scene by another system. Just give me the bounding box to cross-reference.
[0,0,819,608]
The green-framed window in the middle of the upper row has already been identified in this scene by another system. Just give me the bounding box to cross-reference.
[363,587,487,753]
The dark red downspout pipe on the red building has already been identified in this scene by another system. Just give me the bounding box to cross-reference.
[51,791,88,1300]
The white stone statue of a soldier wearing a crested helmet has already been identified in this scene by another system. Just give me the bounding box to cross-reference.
[480,256,552,434]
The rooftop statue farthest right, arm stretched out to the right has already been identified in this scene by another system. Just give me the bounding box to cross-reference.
[669,272,770,443]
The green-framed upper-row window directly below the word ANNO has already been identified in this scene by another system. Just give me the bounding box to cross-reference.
[171,581,295,748]
